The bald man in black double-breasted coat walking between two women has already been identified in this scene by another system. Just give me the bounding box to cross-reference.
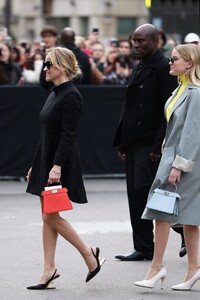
[113,24,186,261]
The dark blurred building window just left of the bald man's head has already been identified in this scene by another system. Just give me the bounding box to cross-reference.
[117,17,136,37]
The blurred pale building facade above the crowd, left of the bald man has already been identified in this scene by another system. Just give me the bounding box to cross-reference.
[0,0,149,41]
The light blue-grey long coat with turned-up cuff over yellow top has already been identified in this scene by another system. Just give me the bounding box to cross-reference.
[142,84,200,225]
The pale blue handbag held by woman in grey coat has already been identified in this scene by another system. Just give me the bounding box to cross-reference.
[146,184,181,216]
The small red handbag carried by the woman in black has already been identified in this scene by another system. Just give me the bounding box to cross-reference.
[41,185,73,214]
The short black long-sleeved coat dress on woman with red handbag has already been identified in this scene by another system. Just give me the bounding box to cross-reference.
[27,82,87,203]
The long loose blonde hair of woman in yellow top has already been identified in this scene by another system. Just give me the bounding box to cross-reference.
[174,44,200,86]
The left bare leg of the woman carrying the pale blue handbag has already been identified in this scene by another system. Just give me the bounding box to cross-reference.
[145,220,170,280]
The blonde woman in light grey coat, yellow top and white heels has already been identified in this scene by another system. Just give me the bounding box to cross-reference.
[135,44,200,290]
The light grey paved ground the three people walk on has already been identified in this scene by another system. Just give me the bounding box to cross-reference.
[0,179,200,300]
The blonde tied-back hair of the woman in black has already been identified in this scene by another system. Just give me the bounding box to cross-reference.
[46,47,82,80]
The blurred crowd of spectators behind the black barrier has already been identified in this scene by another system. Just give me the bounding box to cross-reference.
[0,25,198,88]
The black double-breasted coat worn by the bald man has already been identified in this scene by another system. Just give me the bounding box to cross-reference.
[113,50,177,153]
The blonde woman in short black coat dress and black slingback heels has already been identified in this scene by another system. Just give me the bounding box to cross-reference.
[27,47,105,290]
